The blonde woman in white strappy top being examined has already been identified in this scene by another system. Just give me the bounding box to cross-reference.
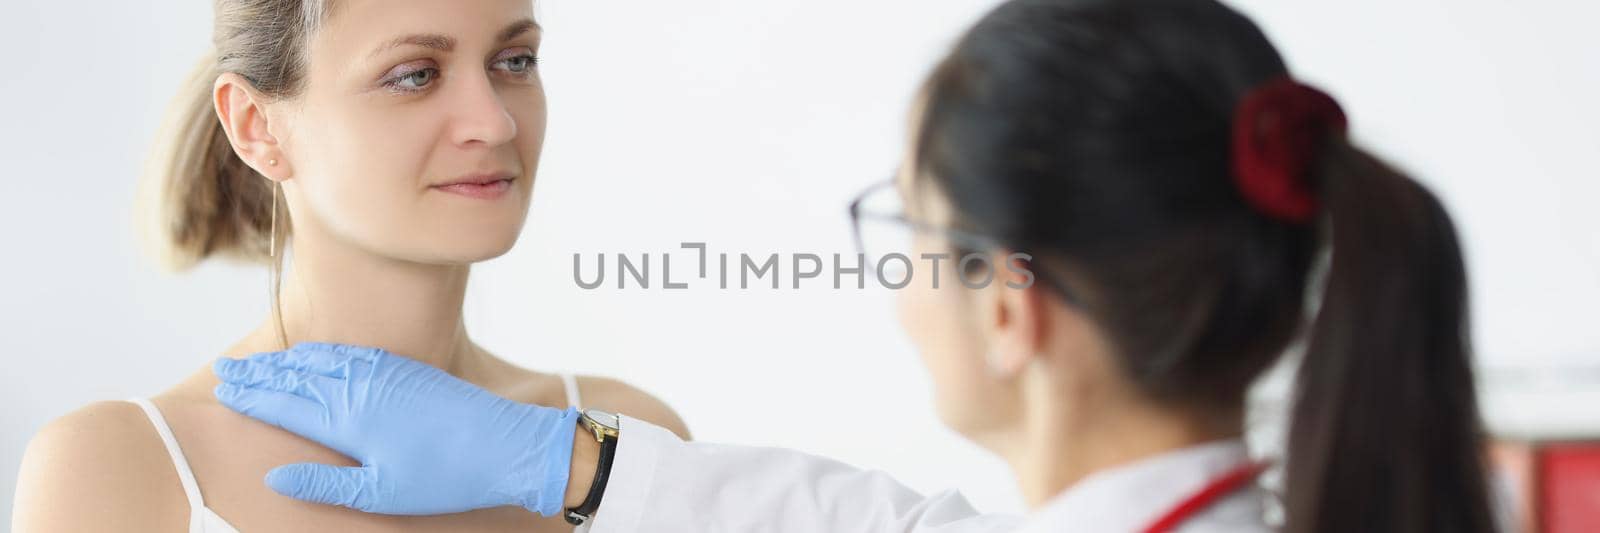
[13,0,686,533]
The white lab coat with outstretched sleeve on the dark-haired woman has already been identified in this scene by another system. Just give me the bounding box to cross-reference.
[589,416,1270,533]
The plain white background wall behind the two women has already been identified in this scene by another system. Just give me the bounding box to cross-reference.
[0,0,1600,525]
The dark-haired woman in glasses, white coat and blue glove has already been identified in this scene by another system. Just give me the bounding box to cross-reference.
[190,0,1494,533]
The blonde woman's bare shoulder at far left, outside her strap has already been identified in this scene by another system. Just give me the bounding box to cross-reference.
[11,402,187,531]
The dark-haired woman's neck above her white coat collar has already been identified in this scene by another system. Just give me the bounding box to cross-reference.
[1003,371,1243,507]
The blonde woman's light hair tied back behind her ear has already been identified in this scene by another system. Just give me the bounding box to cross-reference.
[134,0,331,344]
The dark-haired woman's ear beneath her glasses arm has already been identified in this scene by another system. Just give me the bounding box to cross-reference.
[982,251,1050,378]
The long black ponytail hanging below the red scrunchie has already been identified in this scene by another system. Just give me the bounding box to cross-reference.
[1285,142,1493,531]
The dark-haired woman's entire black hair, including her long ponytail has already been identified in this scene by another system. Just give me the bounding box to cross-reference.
[914,0,1494,533]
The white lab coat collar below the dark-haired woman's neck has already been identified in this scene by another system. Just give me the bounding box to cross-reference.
[1019,439,1266,533]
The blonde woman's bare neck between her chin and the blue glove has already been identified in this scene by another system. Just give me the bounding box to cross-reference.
[235,235,483,378]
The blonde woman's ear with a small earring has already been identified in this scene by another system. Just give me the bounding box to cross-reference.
[211,72,293,181]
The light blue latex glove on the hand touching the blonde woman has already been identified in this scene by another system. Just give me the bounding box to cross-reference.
[213,343,578,515]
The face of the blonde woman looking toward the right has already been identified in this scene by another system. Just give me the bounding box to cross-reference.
[275,0,546,264]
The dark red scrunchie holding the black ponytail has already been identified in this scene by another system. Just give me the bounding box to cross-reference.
[1234,75,1347,224]
